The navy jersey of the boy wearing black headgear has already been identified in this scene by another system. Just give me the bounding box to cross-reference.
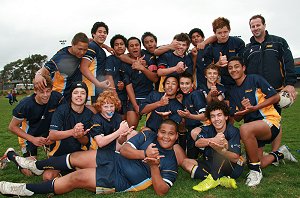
[49,104,93,156]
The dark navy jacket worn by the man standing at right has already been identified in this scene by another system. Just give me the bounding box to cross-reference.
[243,31,297,90]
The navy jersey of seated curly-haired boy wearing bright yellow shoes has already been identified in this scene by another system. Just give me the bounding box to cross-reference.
[198,123,241,159]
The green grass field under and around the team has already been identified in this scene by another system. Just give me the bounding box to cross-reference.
[0,90,300,198]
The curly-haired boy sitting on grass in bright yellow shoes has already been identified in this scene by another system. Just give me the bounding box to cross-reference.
[182,101,243,192]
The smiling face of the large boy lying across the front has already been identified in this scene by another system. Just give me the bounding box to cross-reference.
[157,123,178,149]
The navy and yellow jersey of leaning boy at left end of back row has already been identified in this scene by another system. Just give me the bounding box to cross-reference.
[44,47,82,100]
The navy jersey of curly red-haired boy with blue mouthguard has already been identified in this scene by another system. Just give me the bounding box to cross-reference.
[89,113,122,151]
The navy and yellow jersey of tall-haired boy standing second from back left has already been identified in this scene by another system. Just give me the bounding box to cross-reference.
[83,41,106,96]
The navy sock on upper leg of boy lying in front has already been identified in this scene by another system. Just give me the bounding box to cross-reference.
[35,154,73,171]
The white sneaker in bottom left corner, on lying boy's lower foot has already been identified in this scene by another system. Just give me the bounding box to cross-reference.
[0,181,34,196]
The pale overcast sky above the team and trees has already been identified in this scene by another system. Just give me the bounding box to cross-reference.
[0,0,300,70]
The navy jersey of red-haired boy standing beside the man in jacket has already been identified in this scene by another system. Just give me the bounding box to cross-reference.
[204,36,245,87]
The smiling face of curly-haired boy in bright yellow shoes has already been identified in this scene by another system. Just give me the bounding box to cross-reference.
[210,109,228,133]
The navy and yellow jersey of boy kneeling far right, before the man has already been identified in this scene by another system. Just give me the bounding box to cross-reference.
[229,74,281,128]
